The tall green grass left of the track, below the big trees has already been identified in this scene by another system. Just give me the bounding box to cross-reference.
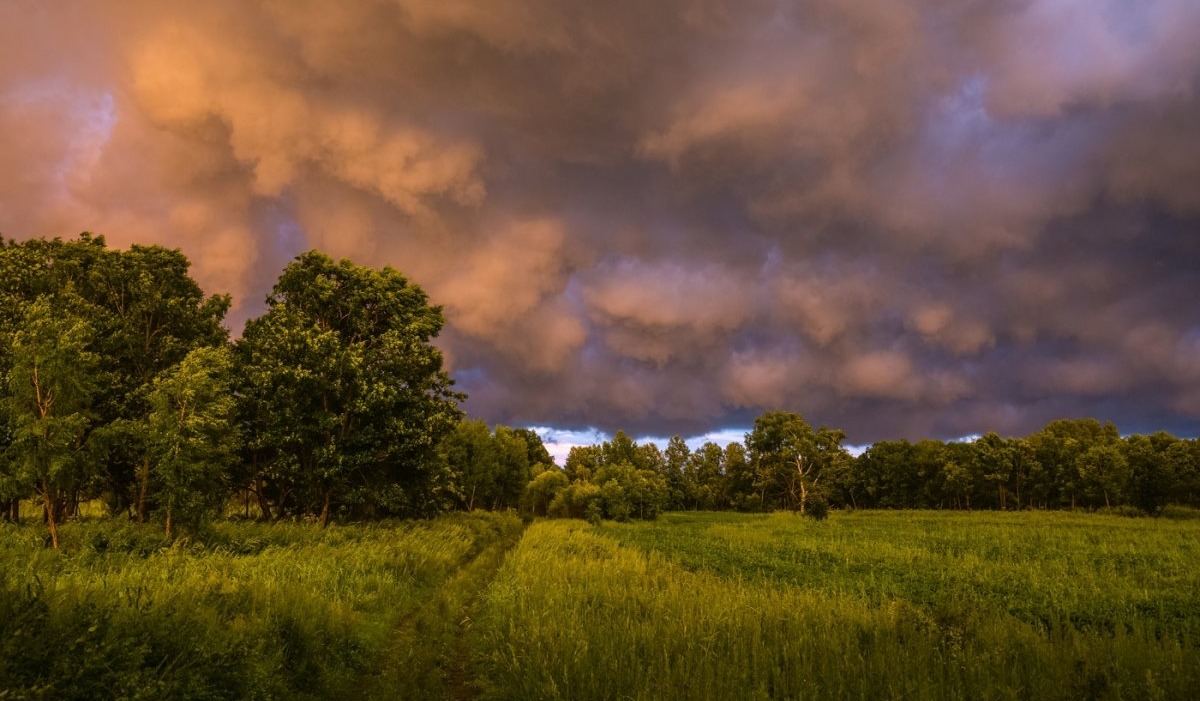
[0,515,520,699]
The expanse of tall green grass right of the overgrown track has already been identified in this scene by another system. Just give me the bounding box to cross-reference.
[474,514,1200,700]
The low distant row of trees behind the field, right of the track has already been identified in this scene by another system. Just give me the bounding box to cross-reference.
[529,412,1200,517]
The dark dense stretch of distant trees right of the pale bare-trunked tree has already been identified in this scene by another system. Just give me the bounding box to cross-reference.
[822,419,1200,514]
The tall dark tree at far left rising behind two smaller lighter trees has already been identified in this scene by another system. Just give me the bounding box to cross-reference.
[0,233,229,519]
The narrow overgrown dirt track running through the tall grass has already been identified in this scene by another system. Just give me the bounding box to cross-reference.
[355,520,522,701]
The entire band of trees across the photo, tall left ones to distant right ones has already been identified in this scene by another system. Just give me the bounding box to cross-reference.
[0,234,1200,546]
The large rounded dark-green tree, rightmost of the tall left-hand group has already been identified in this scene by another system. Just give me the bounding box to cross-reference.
[238,251,462,525]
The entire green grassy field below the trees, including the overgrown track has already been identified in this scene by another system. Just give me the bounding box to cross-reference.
[0,511,1200,700]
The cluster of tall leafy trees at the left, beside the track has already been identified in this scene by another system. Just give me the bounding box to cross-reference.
[0,234,462,547]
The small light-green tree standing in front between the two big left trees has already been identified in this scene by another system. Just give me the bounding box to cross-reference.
[146,347,239,538]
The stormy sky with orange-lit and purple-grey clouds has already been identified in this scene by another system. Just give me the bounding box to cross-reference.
[0,0,1200,444]
